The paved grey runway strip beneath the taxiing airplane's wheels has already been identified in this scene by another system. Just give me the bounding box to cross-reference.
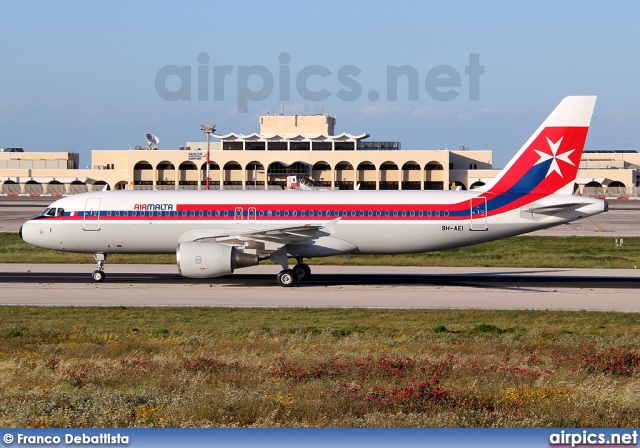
[0,264,640,312]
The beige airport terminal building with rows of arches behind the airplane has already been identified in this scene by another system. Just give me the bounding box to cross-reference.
[0,114,640,197]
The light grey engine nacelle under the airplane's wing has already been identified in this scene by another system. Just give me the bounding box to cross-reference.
[176,241,259,278]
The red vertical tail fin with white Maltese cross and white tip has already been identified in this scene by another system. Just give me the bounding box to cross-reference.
[483,96,596,196]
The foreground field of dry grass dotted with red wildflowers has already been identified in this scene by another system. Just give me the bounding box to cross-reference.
[0,307,640,427]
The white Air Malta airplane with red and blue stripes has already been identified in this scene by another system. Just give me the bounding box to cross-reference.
[20,96,608,287]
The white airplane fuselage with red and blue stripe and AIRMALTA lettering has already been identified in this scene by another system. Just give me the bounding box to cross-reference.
[21,190,606,258]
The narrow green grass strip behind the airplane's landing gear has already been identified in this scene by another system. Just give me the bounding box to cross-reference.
[0,233,640,269]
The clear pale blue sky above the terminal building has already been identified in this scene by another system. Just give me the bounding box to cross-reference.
[0,0,640,167]
